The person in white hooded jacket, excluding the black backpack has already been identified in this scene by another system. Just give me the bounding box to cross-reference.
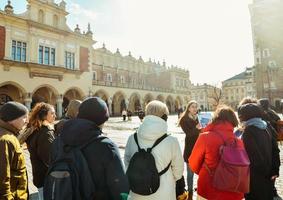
[124,100,184,200]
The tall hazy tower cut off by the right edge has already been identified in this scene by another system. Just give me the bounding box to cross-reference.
[249,0,283,108]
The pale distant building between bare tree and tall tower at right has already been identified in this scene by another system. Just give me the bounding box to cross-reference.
[222,67,256,109]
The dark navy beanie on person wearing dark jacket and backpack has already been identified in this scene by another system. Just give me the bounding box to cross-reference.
[77,97,109,126]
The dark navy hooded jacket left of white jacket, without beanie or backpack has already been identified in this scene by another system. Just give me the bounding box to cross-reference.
[56,119,129,200]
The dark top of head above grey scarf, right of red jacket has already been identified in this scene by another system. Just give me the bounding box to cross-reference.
[238,103,262,121]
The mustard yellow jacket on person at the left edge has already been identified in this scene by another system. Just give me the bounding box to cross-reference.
[0,120,28,200]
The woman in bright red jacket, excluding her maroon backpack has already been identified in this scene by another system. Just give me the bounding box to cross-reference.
[189,105,244,200]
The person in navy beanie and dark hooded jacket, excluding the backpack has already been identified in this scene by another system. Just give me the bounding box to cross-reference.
[52,97,129,200]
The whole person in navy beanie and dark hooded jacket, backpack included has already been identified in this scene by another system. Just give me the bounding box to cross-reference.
[44,97,129,200]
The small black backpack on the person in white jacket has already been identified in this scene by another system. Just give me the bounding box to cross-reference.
[126,133,171,195]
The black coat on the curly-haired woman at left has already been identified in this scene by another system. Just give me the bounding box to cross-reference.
[26,125,55,188]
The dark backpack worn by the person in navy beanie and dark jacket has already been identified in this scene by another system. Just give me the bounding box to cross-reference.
[43,136,105,200]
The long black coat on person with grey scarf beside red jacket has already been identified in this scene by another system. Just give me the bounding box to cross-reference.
[242,126,276,200]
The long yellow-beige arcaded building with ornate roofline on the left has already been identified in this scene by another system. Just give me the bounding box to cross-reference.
[0,0,191,117]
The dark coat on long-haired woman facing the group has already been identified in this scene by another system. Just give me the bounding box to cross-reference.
[179,115,200,163]
